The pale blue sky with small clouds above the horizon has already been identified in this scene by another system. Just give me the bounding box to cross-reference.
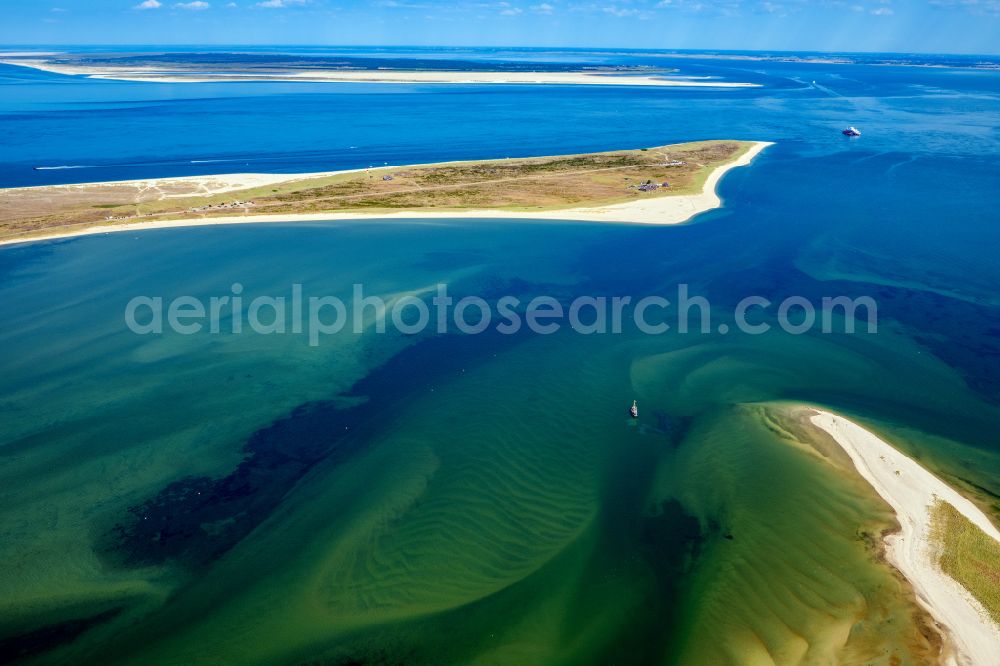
[0,0,1000,54]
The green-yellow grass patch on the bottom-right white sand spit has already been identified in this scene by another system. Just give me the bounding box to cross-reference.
[931,500,1000,623]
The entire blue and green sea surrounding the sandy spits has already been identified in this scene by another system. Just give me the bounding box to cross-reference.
[0,50,1000,663]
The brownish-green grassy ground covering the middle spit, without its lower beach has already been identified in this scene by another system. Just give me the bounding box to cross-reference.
[0,140,753,238]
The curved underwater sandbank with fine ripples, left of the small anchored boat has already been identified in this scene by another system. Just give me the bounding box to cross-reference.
[322,342,601,619]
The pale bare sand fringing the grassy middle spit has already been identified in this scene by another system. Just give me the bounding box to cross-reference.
[0,141,773,246]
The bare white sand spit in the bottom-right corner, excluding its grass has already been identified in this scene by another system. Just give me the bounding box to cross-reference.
[811,410,1000,666]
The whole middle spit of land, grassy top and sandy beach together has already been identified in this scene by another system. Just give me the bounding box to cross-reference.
[0,140,770,243]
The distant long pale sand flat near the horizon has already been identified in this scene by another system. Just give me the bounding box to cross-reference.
[0,59,760,88]
